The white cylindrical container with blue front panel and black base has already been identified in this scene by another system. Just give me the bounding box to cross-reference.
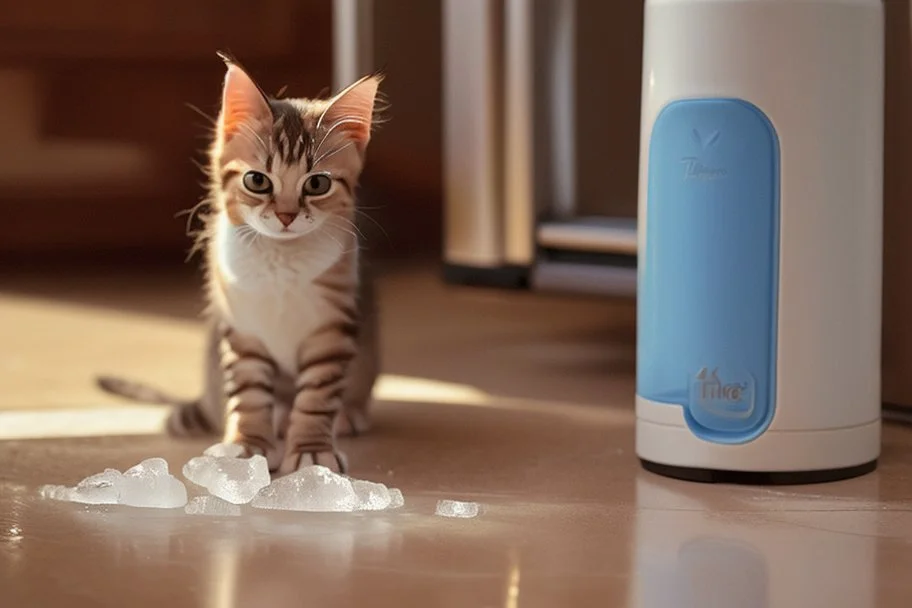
[636,0,884,483]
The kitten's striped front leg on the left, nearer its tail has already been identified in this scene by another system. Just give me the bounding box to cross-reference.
[221,329,282,470]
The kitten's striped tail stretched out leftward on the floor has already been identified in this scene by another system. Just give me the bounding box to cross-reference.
[97,376,221,437]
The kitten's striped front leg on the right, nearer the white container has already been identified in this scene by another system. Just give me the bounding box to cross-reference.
[279,321,355,474]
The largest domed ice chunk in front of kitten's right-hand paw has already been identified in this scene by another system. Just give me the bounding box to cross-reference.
[250,465,361,511]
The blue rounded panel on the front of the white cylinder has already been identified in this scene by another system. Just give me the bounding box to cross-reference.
[637,99,780,444]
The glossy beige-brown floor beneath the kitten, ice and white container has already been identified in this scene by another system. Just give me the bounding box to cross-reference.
[0,269,912,608]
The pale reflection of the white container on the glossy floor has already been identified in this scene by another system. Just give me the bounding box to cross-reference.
[630,475,881,608]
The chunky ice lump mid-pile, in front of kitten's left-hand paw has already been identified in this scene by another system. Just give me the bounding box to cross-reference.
[184,454,270,505]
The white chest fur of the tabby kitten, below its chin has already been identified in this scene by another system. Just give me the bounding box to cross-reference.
[212,216,350,374]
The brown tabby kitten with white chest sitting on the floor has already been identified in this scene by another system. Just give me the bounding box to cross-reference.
[99,56,381,474]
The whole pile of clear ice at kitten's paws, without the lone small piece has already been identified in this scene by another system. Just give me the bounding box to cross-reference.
[41,444,405,516]
